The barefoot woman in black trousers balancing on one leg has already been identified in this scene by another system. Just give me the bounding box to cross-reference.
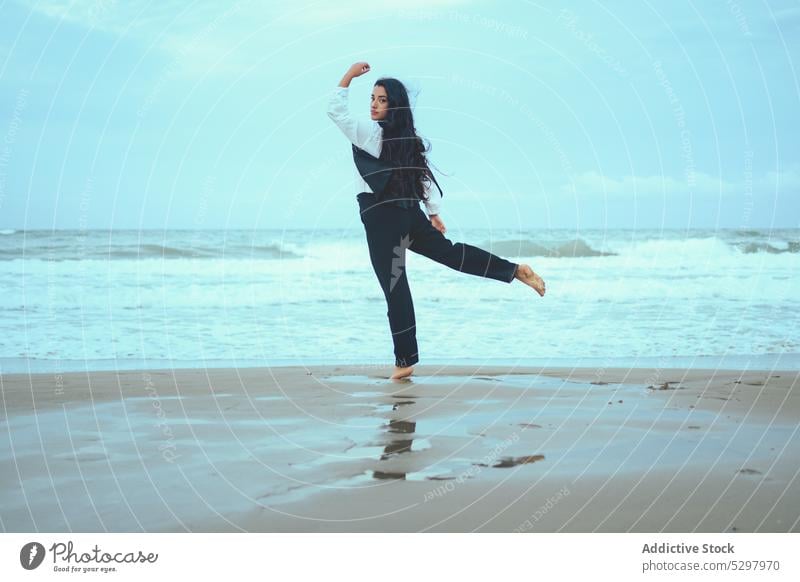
[328,62,545,379]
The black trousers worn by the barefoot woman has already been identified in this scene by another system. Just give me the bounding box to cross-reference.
[357,192,517,367]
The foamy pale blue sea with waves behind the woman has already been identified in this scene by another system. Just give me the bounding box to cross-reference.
[0,228,800,373]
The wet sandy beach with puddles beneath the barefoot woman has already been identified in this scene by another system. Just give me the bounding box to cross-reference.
[0,365,800,532]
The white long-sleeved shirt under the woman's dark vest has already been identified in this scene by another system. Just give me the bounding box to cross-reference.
[328,87,442,215]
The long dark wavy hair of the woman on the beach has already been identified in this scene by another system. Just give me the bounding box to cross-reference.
[375,77,433,205]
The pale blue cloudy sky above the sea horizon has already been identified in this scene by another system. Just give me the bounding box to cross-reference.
[0,0,800,229]
